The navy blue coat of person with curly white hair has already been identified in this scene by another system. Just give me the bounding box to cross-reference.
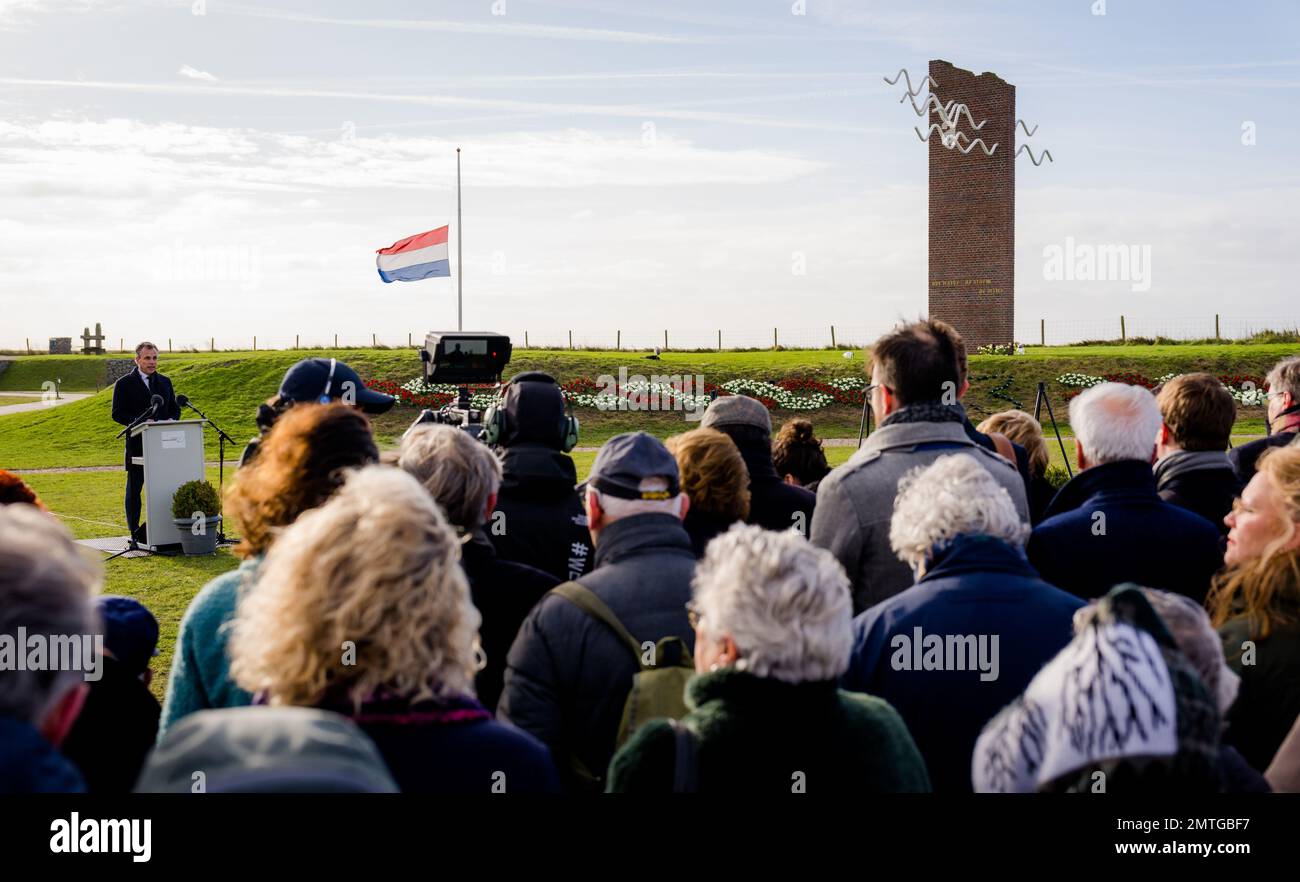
[841,536,1083,794]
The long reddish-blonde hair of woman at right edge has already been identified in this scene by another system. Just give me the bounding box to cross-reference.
[1205,445,1300,639]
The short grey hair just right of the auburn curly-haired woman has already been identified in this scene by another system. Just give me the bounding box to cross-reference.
[398,425,501,529]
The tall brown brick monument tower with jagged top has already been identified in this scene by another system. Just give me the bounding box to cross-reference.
[922,60,1015,353]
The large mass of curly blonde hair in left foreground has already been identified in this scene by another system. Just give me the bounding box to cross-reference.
[230,466,481,709]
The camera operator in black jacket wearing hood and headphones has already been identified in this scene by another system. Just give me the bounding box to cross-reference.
[485,371,592,581]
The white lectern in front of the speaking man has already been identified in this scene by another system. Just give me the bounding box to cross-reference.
[131,420,208,552]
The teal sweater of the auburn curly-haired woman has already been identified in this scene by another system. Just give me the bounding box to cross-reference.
[159,557,261,739]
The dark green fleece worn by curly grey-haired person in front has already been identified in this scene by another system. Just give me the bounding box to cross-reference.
[607,669,930,795]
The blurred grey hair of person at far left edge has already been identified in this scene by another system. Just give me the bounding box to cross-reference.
[0,503,103,726]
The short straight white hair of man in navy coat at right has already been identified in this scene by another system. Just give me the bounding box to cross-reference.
[1070,382,1161,466]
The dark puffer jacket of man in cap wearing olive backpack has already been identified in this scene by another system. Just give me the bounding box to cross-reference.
[497,514,696,790]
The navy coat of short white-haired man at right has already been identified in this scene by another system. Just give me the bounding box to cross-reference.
[1026,459,1223,604]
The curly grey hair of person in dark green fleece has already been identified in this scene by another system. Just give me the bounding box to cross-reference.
[692,524,853,683]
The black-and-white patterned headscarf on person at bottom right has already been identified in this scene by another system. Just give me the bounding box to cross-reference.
[971,585,1219,792]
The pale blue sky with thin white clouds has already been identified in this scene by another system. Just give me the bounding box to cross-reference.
[0,0,1300,349]
